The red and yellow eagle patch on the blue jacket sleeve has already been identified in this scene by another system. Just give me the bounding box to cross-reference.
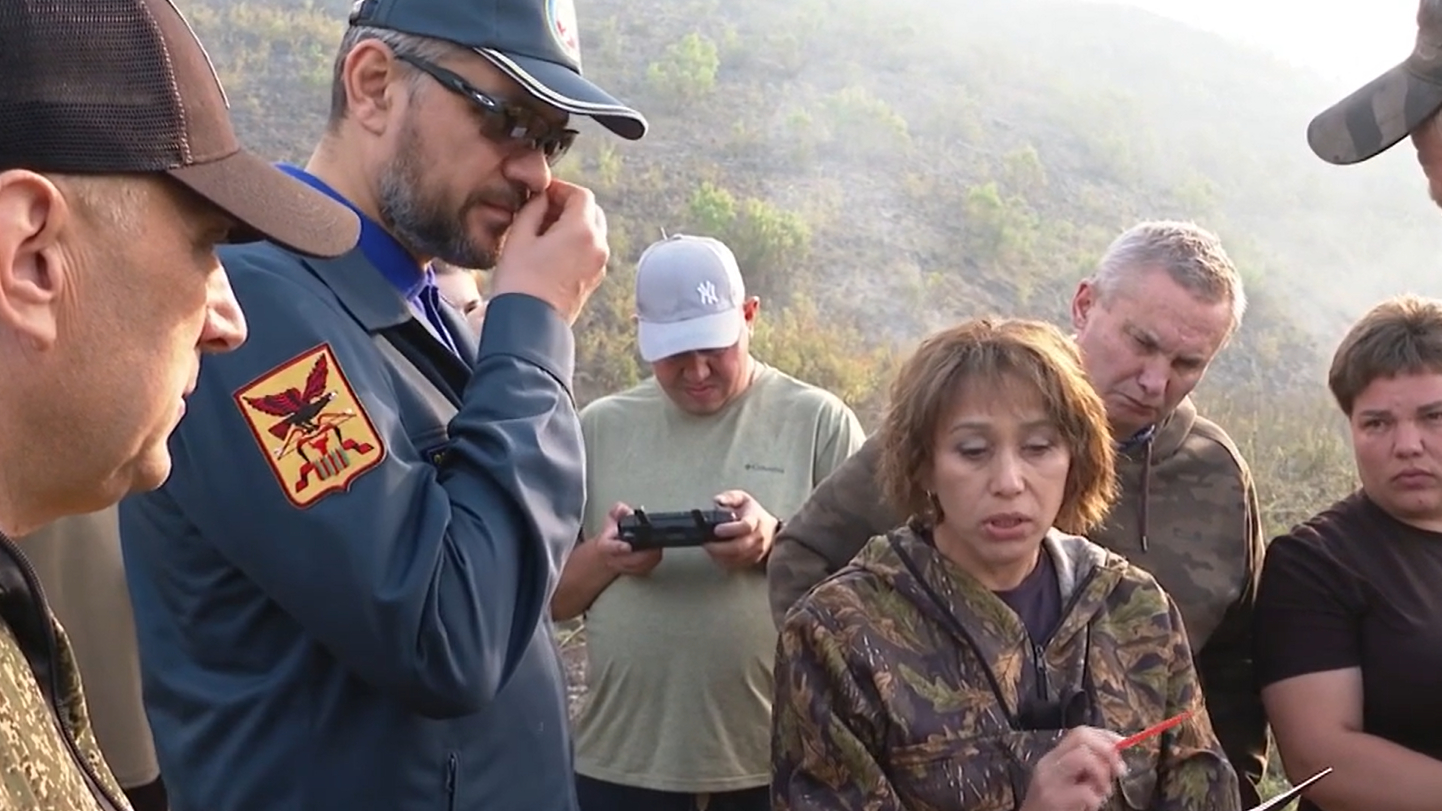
[234,343,385,508]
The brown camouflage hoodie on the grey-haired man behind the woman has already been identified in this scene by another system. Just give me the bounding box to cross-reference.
[767,400,1268,805]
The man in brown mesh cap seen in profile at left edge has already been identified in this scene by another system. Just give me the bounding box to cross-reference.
[0,0,358,811]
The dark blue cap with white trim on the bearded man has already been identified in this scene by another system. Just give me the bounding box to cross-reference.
[350,0,647,140]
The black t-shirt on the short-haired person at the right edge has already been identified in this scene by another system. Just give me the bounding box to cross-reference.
[1255,492,1442,811]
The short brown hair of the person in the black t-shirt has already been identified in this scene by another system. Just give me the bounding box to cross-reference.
[1327,293,1442,417]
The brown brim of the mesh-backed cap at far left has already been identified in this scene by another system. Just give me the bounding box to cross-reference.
[167,150,361,258]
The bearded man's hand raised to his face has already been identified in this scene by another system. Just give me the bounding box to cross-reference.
[492,180,610,325]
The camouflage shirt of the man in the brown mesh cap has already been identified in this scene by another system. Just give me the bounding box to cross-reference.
[0,535,130,811]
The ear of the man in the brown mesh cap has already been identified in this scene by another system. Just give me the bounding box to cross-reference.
[0,169,72,349]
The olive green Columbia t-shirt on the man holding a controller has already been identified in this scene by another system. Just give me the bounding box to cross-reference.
[575,364,865,794]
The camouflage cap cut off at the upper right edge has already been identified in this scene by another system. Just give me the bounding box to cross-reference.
[1306,0,1442,165]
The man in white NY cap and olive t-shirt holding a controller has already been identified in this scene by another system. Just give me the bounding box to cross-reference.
[551,235,865,811]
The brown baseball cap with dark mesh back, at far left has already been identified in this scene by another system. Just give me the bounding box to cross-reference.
[0,0,361,257]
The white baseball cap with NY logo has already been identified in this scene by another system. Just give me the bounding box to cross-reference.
[636,234,746,364]
